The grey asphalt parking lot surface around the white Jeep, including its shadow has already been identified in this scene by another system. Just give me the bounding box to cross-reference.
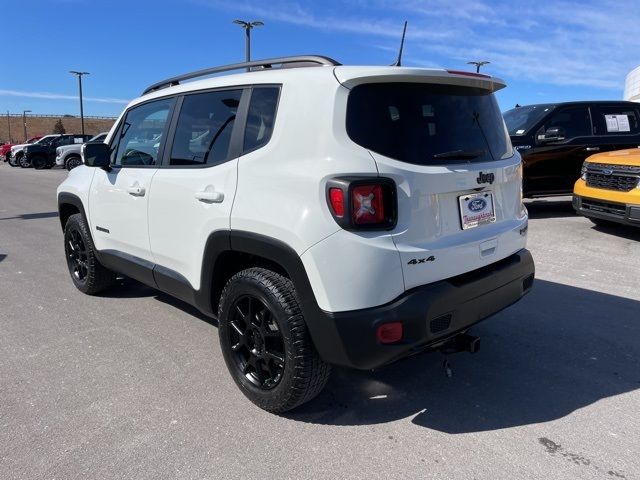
[0,163,640,480]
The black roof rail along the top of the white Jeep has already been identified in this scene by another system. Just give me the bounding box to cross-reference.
[142,55,340,95]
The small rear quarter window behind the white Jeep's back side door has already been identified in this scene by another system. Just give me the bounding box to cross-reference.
[242,87,280,153]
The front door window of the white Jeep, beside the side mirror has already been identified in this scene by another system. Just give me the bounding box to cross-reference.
[112,99,174,166]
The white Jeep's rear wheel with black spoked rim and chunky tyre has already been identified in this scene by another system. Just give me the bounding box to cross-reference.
[218,268,331,413]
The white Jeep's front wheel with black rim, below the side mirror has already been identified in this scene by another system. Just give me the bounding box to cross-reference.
[64,213,116,295]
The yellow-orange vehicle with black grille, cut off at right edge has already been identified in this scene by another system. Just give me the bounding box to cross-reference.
[573,148,640,227]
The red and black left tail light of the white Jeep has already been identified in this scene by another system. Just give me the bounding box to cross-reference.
[327,177,397,230]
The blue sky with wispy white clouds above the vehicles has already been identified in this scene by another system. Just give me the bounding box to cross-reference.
[0,0,640,116]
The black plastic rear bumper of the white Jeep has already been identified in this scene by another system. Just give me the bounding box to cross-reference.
[314,249,535,369]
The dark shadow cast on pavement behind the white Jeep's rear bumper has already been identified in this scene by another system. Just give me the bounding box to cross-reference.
[286,280,640,434]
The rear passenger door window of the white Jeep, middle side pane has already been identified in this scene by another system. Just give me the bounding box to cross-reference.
[169,90,242,165]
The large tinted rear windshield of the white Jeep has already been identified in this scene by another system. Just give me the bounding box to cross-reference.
[347,83,513,165]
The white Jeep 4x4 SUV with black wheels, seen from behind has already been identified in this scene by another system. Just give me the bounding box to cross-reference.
[58,56,534,412]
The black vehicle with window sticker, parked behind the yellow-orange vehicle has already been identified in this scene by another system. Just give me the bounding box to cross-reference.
[503,101,640,198]
